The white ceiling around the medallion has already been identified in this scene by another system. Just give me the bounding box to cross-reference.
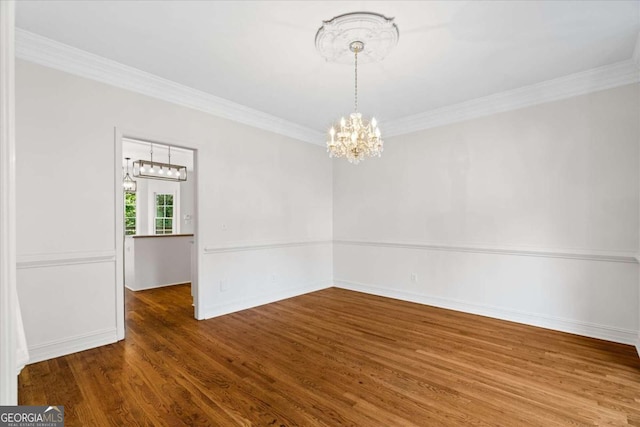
[17,1,640,130]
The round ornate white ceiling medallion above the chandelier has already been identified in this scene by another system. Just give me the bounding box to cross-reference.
[316,12,400,64]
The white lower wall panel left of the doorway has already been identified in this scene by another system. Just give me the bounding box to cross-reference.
[17,254,117,363]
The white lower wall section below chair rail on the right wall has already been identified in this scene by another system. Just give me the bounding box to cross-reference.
[334,241,638,344]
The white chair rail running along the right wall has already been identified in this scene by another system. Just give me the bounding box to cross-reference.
[333,240,638,264]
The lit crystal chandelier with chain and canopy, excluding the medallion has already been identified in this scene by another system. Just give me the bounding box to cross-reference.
[327,41,384,164]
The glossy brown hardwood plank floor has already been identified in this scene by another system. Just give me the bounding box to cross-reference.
[19,285,640,426]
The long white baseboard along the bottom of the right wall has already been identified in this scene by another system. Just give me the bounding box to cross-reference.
[334,279,638,345]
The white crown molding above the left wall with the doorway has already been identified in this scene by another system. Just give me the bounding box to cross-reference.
[16,29,324,145]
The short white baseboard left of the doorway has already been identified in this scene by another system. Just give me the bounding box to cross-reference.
[29,328,118,364]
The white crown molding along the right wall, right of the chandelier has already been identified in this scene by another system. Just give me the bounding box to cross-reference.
[382,59,640,137]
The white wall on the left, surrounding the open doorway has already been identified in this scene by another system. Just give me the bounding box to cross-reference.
[16,61,332,361]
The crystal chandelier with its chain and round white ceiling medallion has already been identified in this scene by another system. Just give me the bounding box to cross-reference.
[316,12,399,164]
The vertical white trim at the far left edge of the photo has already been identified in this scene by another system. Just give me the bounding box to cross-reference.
[0,0,19,405]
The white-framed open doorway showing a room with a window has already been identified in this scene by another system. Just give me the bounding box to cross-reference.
[115,130,198,339]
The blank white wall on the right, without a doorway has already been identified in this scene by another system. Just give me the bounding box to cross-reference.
[334,85,640,343]
